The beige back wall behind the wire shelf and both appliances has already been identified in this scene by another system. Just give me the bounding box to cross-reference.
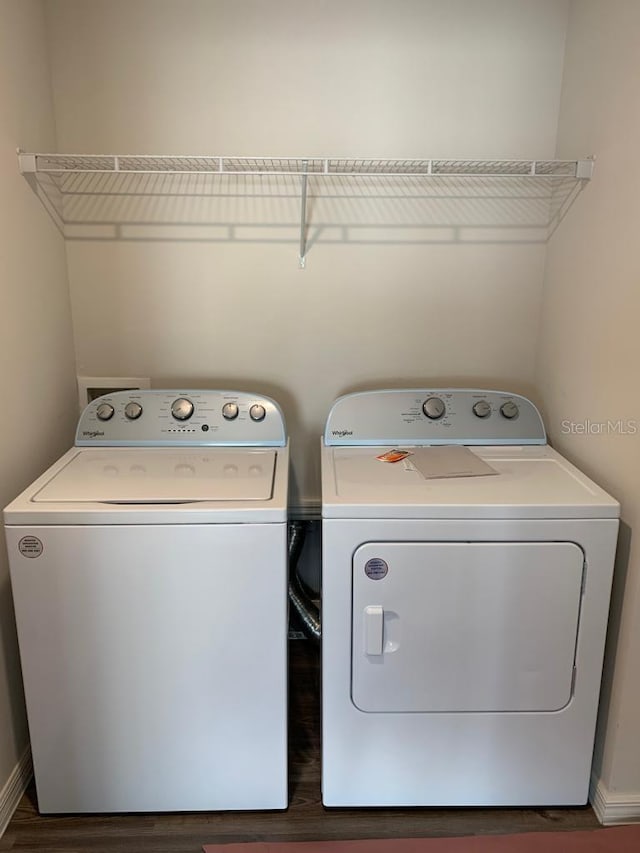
[46,0,574,501]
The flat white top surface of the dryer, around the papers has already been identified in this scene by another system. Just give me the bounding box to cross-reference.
[322,446,620,518]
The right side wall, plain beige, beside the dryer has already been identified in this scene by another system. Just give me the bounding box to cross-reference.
[537,0,640,819]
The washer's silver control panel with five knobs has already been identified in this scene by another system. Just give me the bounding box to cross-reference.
[75,389,287,447]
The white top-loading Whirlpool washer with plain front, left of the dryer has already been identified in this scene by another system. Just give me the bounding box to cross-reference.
[4,390,289,813]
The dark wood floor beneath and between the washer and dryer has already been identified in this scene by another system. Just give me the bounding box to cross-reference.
[0,640,598,853]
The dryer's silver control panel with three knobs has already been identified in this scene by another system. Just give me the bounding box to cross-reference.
[324,388,547,445]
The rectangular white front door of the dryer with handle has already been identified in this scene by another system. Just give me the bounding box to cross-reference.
[351,542,584,712]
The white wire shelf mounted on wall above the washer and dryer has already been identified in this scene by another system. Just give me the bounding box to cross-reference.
[18,151,593,266]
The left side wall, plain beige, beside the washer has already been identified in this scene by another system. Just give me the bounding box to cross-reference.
[0,0,77,800]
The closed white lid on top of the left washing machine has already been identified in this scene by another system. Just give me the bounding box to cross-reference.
[32,447,276,504]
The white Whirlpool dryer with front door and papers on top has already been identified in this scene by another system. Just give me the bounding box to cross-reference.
[322,389,619,806]
